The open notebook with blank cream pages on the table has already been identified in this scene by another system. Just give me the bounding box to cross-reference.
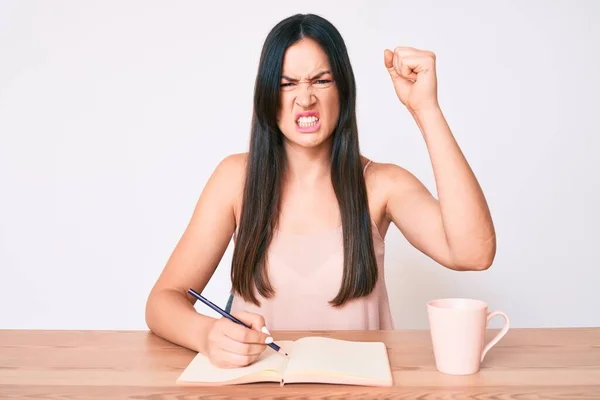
[177,336,393,386]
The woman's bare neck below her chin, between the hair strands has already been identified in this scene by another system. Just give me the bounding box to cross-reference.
[285,140,333,184]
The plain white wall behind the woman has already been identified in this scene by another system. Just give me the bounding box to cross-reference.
[0,0,600,329]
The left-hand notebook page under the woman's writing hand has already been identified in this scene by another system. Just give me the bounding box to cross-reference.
[177,341,294,384]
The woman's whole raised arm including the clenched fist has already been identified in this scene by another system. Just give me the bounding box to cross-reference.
[380,47,496,270]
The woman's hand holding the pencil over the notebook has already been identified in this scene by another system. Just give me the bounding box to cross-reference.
[204,312,273,368]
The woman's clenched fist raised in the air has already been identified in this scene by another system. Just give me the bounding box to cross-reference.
[384,47,439,113]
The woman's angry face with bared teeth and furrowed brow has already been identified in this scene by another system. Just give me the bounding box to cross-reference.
[277,39,340,148]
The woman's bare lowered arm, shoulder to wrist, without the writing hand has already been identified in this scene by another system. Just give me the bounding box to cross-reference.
[146,155,243,353]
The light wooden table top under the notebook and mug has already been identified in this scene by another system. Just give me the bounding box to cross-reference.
[0,328,600,400]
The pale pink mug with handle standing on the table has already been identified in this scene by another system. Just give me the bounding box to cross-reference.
[427,299,510,375]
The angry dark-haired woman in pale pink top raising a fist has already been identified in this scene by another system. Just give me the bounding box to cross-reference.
[146,15,495,367]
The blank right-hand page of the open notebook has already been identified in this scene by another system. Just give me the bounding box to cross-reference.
[284,337,392,385]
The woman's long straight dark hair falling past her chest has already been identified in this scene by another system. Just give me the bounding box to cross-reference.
[231,14,378,307]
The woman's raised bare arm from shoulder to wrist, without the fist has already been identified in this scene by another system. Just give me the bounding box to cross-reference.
[386,109,496,270]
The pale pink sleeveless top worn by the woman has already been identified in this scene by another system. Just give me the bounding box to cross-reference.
[231,161,394,330]
